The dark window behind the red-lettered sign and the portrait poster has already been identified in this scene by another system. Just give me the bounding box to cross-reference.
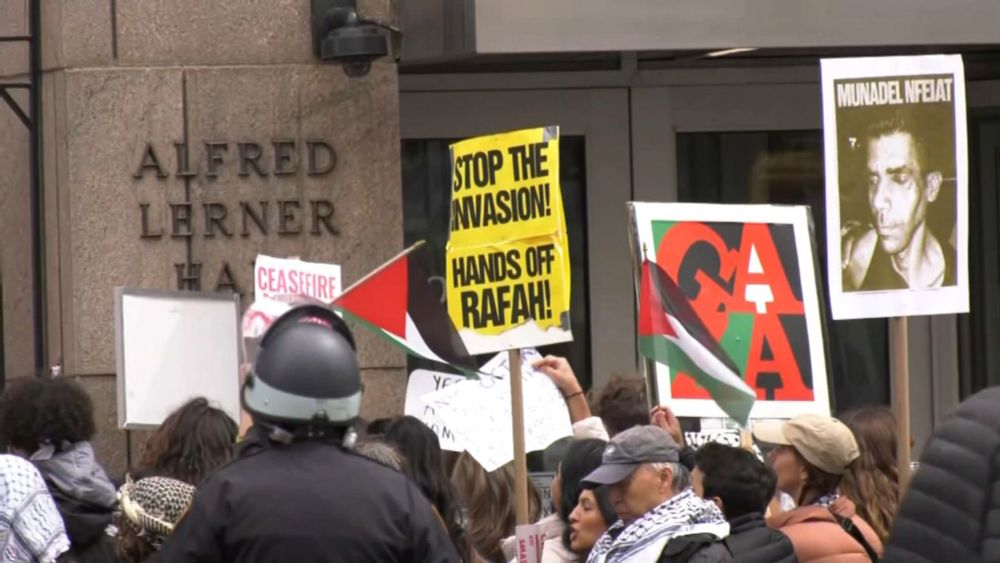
[677,131,889,413]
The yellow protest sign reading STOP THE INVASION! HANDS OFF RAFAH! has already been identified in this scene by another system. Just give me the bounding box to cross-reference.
[446,127,573,354]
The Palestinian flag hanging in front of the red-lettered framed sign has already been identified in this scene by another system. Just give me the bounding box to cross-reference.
[639,260,756,425]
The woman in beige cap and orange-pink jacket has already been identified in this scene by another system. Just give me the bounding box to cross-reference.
[753,414,882,563]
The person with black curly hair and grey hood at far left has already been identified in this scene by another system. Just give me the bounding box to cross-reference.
[0,378,117,563]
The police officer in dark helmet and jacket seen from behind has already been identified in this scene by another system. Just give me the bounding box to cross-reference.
[158,305,459,563]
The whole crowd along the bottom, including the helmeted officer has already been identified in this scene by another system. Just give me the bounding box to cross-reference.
[0,306,1000,563]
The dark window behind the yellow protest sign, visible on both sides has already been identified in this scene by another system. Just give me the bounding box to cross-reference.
[402,137,591,388]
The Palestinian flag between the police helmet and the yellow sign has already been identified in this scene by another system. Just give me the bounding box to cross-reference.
[331,241,475,370]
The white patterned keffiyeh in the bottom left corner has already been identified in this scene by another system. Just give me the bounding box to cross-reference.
[0,455,69,563]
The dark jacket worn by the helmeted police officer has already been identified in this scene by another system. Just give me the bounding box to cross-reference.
[157,432,459,563]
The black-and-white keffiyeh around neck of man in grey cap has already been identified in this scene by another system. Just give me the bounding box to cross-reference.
[587,489,729,563]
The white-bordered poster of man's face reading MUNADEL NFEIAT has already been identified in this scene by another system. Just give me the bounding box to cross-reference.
[822,56,968,318]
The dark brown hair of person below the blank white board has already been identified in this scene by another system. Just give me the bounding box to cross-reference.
[132,397,237,487]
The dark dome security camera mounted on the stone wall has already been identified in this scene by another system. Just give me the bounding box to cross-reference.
[312,0,398,77]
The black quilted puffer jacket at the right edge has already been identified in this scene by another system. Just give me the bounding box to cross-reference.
[883,387,1000,563]
